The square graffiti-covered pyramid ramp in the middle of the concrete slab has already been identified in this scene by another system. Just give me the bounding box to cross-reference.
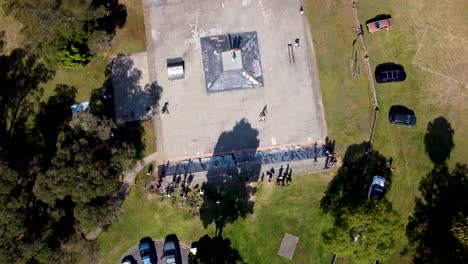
[200,31,263,93]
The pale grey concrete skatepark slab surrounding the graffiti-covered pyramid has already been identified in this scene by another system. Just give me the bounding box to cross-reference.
[146,0,326,159]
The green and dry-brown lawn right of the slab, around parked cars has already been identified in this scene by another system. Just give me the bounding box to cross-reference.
[307,0,468,263]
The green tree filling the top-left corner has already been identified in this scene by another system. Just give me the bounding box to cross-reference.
[2,0,114,66]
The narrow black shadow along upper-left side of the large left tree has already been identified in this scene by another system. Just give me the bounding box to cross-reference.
[35,84,77,168]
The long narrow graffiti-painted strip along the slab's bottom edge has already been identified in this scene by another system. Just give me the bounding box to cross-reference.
[164,145,326,175]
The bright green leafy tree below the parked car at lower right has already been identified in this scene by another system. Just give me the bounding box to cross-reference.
[323,200,404,263]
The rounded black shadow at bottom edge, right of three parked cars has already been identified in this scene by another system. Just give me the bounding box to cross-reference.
[188,235,244,264]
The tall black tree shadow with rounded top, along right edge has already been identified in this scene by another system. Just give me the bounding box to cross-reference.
[406,117,468,263]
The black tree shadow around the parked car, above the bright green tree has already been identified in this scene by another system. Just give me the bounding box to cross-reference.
[320,142,392,214]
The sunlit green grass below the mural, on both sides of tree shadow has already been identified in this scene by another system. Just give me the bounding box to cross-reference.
[97,172,332,263]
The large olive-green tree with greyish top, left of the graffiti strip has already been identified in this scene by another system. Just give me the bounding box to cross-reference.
[34,112,133,204]
